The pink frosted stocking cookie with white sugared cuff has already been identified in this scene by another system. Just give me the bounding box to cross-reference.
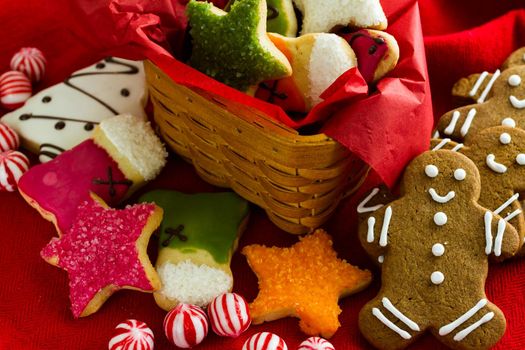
[19,115,166,235]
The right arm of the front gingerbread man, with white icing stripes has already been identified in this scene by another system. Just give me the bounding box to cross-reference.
[483,210,521,261]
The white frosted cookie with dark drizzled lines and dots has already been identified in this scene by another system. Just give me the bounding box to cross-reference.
[2,57,148,162]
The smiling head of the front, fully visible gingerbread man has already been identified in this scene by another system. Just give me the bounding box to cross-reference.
[401,150,480,204]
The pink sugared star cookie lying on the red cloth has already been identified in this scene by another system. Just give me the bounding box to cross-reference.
[40,195,163,317]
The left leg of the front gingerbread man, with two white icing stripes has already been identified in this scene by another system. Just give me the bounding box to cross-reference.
[359,296,426,350]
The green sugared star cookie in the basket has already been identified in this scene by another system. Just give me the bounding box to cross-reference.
[186,0,292,91]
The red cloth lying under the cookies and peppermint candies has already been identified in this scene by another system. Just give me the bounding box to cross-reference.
[0,0,525,350]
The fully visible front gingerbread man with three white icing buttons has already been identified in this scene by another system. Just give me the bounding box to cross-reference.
[359,150,519,349]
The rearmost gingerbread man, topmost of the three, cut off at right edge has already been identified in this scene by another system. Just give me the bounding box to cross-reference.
[437,49,525,142]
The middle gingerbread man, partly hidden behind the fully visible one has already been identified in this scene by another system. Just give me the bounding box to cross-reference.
[432,126,525,255]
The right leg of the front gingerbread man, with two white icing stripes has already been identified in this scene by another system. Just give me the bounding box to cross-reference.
[432,298,506,350]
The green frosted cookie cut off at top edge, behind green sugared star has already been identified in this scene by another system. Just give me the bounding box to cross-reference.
[226,0,297,37]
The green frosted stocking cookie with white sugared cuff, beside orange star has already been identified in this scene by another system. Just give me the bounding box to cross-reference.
[139,190,249,310]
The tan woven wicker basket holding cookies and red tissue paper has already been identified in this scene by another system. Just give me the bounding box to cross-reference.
[145,61,369,234]
